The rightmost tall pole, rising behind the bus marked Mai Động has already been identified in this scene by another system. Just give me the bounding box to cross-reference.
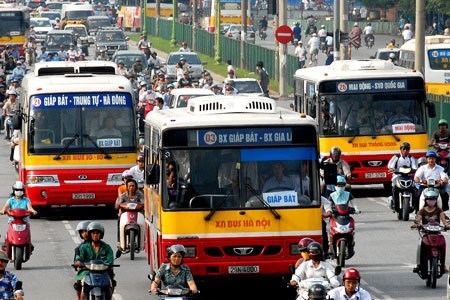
[414,0,425,77]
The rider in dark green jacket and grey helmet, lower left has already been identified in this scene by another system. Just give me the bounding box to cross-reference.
[74,222,116,300]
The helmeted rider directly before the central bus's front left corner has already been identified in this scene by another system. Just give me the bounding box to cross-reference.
[150,244,198,294]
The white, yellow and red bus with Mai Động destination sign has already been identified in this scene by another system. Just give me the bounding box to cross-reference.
[294,60,436,191]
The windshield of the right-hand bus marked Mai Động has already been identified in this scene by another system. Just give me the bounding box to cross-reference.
[319,92,426,136]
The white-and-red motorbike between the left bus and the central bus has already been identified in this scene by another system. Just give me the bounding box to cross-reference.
[116,202,144,260]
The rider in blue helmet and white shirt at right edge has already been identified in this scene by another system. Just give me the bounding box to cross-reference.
[414,151,449,212]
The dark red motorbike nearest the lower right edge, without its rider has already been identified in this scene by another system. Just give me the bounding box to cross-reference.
[413,222,446,289]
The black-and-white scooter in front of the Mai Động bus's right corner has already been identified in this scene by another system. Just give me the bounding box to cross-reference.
[389,167,415,221]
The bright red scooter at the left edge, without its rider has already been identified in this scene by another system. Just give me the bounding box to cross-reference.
[2,208,34,270]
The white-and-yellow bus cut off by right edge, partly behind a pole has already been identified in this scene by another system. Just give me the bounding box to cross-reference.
[399,35,450,95]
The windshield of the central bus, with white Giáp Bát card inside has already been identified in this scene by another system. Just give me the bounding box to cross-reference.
[163,146,320,210]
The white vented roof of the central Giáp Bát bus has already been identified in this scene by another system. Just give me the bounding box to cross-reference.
[145,95,316,128]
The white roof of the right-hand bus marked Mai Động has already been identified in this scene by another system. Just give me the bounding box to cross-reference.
[294,59,423,81]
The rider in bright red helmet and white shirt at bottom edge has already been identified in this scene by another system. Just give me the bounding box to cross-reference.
[328,268,372,300]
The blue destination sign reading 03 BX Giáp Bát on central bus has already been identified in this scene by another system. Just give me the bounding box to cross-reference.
[197,128,292,147]
